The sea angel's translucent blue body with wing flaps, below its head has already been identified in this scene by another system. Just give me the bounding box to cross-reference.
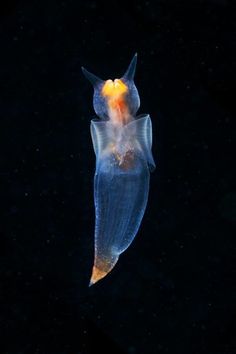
[91,116,155,284]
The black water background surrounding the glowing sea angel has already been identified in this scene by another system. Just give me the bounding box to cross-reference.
[0,0,236,354]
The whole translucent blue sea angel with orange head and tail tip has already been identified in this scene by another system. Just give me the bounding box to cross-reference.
[82,54,155,285]
